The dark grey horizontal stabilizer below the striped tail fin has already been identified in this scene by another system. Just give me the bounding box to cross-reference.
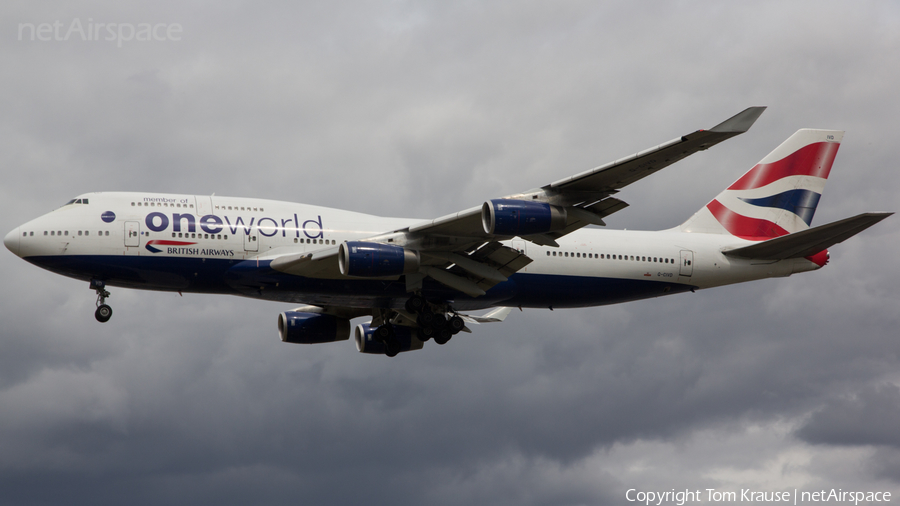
[723,213,894,260]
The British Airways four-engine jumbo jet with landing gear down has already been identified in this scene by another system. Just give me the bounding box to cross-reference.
[3,107,893,357]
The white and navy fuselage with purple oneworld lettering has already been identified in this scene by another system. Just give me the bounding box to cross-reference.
[4,192,819,308]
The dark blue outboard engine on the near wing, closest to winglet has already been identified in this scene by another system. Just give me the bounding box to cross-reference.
[481,199,566,236]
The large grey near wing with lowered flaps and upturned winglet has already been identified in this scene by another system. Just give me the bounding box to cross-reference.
[271,107,765,297]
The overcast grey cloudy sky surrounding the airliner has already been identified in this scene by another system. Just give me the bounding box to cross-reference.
[0,0,900,505]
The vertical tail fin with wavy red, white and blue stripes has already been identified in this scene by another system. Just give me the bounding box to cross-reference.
[680,129,844,241]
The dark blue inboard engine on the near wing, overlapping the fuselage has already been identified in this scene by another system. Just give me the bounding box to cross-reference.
[338,241,419,278]
